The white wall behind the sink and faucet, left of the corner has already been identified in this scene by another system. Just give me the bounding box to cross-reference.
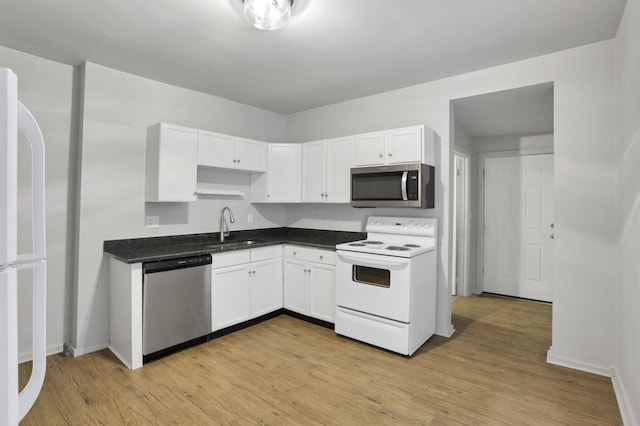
[72,63,286,354]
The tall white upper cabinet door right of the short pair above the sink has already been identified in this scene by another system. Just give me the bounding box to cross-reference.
[266,144,300,203]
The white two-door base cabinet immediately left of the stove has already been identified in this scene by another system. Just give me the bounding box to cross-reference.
[284,245,336,322]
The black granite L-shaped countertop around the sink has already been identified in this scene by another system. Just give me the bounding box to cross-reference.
[104,228,367,263]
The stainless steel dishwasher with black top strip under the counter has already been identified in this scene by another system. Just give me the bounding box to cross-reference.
[142,255,212,362]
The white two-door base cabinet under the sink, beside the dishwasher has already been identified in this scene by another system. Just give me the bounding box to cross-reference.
[211,246,282,331]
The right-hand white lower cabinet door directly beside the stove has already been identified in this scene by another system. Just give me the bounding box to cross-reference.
[308,263,336,322]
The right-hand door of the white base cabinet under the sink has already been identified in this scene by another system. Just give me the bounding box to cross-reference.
[251,259,283,317]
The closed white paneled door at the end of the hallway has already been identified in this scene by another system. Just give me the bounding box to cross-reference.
[483,154,554,302]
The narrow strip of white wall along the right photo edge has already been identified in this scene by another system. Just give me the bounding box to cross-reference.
[614,0,640,425]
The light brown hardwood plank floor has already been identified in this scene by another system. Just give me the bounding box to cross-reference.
[20,296,622,425]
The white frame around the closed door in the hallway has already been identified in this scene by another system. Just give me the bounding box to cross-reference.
[476,147,555,294]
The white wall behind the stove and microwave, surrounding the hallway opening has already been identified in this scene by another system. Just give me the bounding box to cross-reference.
[287,41,615,374]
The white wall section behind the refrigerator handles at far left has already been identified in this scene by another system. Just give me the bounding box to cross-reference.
[0,46,73,360]
